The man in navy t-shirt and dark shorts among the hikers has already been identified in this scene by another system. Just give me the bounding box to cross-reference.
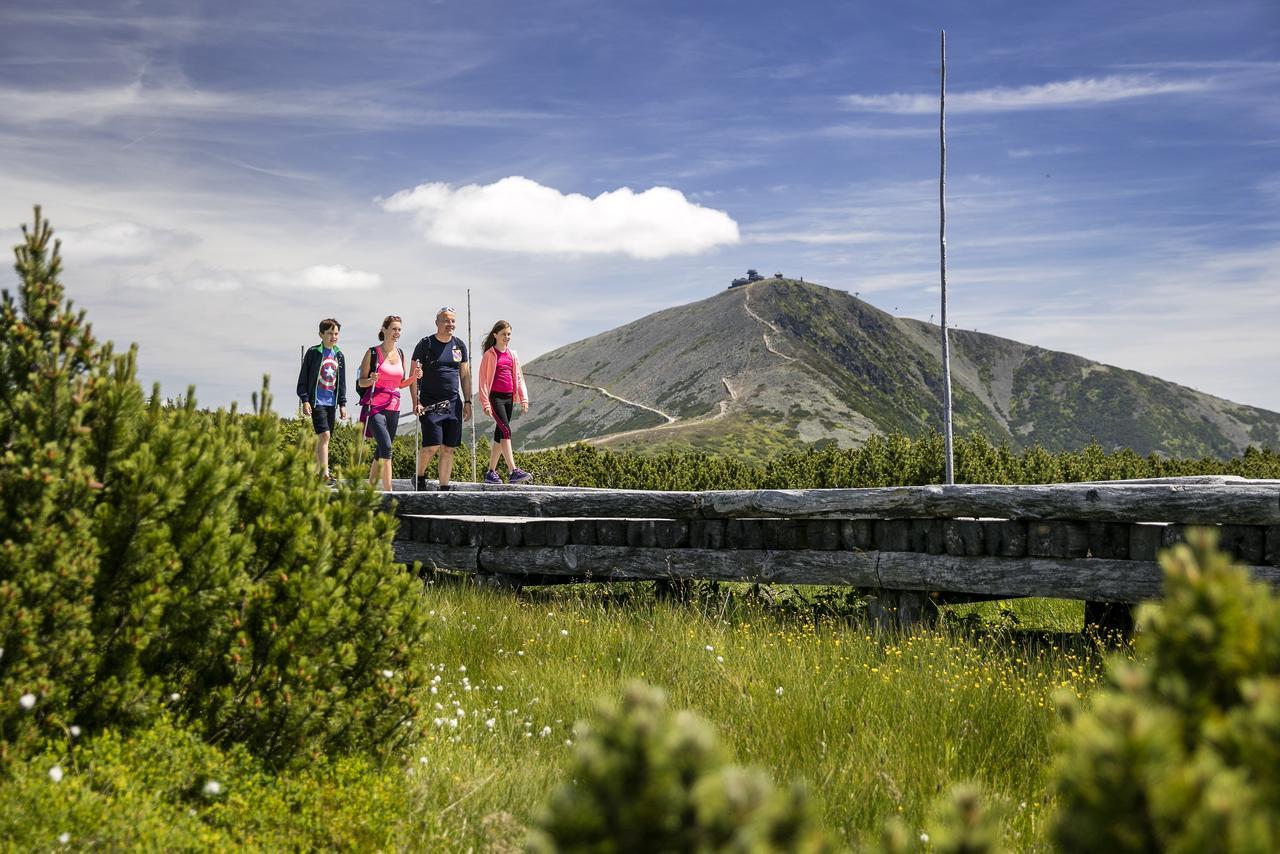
[413,307,471,492]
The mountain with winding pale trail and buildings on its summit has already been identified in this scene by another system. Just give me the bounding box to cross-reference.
[516,278,1280,457]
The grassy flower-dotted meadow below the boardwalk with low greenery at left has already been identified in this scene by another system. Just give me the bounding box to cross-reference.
[0,585,1121,851]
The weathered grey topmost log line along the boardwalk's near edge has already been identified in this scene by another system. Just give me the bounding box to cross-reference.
[385,479,1280,525]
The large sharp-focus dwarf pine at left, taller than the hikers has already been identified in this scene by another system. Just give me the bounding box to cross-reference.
[0,209,426,766]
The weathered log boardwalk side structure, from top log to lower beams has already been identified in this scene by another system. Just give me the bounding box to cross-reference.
[389,478,1280,617]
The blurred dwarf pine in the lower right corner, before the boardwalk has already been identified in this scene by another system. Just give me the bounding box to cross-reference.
[1053,529,1280,854]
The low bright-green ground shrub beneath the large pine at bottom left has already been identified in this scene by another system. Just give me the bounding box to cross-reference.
[0,717,413,851]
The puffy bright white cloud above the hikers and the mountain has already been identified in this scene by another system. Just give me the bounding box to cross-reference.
[381,175,740,259]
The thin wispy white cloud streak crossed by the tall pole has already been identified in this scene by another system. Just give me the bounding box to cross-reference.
[841,74,1212,115]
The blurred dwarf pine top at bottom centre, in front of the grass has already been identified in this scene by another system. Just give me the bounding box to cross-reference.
[527,682,829,854]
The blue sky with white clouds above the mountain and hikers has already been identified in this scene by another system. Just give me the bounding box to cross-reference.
[0,0,1280,411]
